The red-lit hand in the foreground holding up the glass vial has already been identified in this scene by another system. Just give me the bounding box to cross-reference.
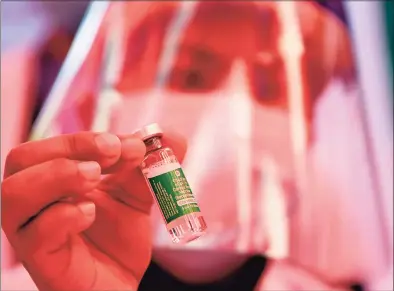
[1,132,186,291]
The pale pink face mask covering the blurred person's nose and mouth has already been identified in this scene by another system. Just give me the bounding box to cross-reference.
[111,61,292,251]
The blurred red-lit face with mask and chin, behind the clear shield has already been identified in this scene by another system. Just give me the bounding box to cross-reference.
[101,2,298,281]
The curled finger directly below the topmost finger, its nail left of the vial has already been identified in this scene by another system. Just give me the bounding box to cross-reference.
[1,159,101,235]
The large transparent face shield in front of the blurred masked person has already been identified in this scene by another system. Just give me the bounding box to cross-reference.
[33,1,390,286]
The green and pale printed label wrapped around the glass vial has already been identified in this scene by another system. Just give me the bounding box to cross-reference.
[146,163,200,223]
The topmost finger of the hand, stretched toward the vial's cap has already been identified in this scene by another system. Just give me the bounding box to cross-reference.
[5,132,121,178]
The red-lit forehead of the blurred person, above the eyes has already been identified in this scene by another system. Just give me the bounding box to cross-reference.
[183,2,278,57]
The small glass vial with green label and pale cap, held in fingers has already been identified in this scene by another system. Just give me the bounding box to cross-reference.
[136,123,207,243]
